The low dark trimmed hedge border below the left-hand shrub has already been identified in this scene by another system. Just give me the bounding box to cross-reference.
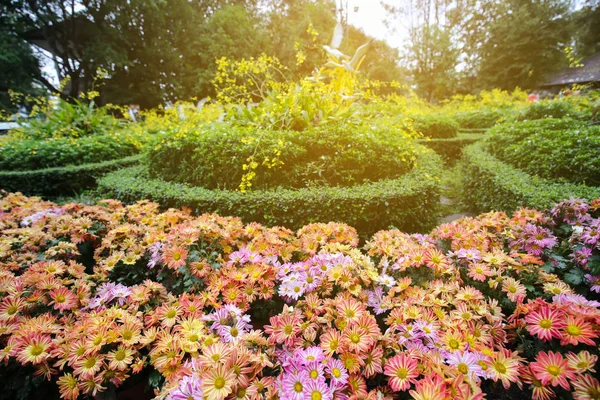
[0,154,142,197]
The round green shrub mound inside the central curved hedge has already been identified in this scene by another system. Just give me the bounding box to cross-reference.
[148,124,415,189]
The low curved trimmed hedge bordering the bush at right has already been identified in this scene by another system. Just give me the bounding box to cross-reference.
[461,142,600,212]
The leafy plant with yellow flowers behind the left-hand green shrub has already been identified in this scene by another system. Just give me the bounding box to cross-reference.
[12,99,119,140]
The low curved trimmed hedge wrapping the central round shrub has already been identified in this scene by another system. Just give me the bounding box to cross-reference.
[98,151,441,236]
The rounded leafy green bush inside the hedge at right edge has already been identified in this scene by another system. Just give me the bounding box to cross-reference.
[486,119,600,186]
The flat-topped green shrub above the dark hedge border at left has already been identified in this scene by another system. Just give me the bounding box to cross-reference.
[0,132,144,171]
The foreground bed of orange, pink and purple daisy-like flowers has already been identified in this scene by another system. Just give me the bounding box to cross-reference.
[0,194,600,400]
